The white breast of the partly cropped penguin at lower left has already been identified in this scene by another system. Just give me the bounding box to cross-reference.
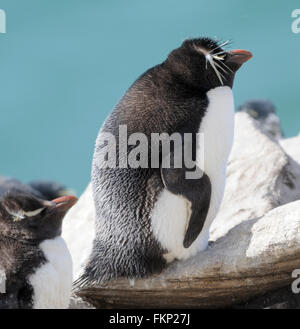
[29,237,72,309]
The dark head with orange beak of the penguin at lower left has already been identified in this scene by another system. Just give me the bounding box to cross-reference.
[0,192,77,243]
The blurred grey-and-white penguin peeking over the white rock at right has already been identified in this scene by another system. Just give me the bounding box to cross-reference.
[238,99,284,140]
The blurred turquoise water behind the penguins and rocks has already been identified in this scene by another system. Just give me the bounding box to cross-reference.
[0,0,300,193]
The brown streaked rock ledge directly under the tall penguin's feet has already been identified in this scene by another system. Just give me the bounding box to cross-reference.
[78,201,300,308]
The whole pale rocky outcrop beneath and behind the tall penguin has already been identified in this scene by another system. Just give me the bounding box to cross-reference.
[63,113,300,308]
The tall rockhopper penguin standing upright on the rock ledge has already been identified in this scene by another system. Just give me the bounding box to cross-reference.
[77,38,252,285]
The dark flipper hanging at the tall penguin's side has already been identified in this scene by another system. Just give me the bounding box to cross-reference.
[161,167,211,248]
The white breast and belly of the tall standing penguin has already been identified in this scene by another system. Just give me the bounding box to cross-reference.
[151,87,234,261]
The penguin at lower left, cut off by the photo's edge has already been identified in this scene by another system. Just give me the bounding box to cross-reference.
[0,191,77,308]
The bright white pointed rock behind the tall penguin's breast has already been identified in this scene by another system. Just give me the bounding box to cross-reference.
[210,112,300,240]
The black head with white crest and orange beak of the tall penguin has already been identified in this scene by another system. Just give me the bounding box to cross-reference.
[166,38,252,91]
